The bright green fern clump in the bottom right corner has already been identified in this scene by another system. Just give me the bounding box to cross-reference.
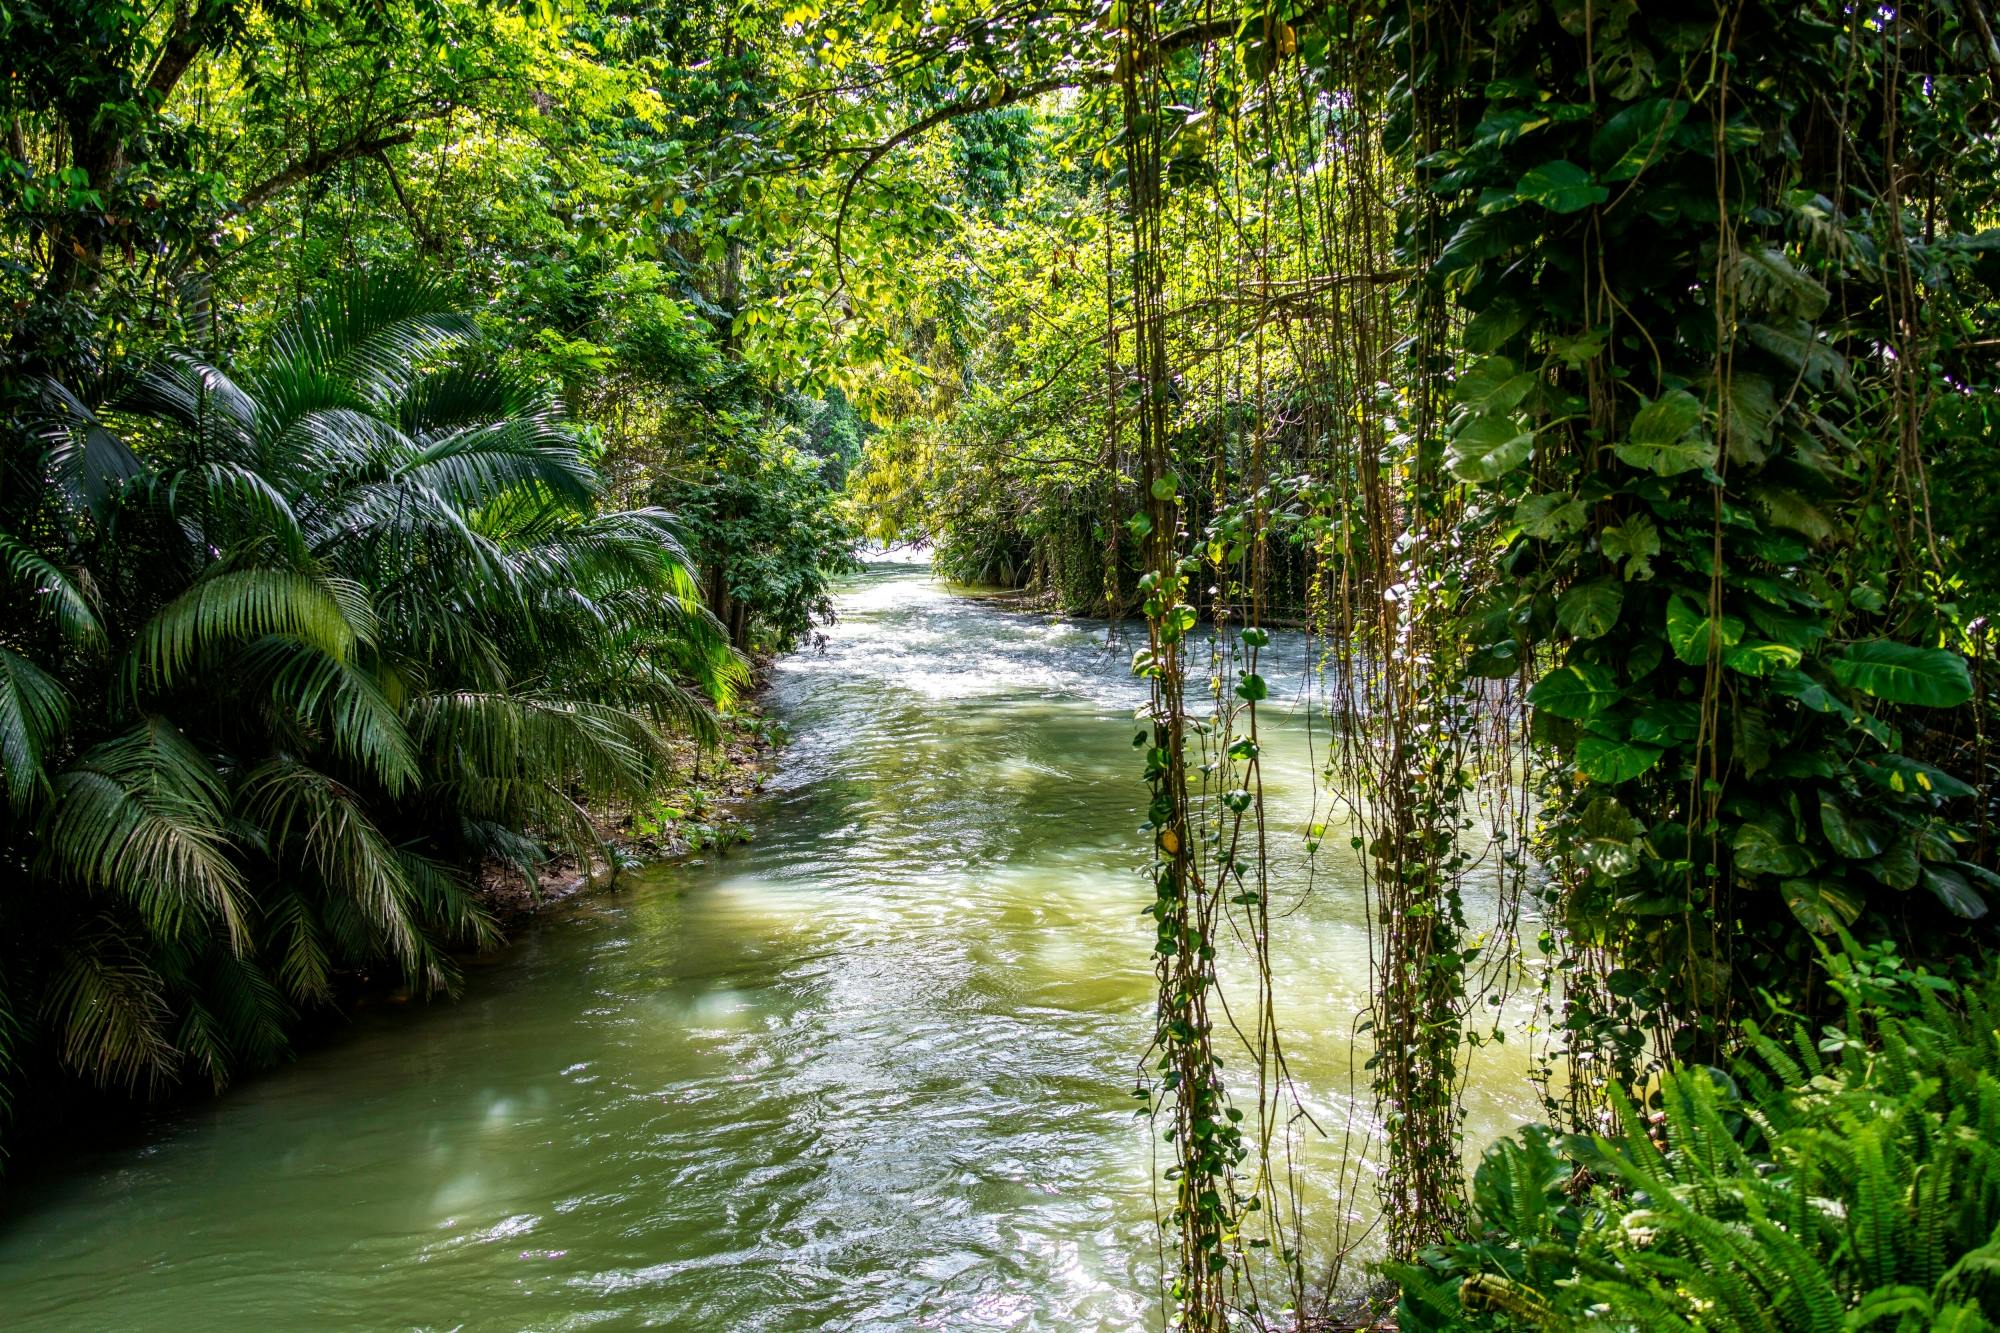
[1398,951,2000,1331]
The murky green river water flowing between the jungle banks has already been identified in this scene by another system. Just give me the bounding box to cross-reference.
[0,560,1536,1333]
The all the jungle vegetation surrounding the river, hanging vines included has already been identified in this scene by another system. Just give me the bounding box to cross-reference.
[11,0,2000,1329]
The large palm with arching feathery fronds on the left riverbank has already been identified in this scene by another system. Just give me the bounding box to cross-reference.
[0,276,744,1128]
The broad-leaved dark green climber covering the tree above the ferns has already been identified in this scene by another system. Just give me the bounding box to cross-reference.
[1392,0,2000,1103]
